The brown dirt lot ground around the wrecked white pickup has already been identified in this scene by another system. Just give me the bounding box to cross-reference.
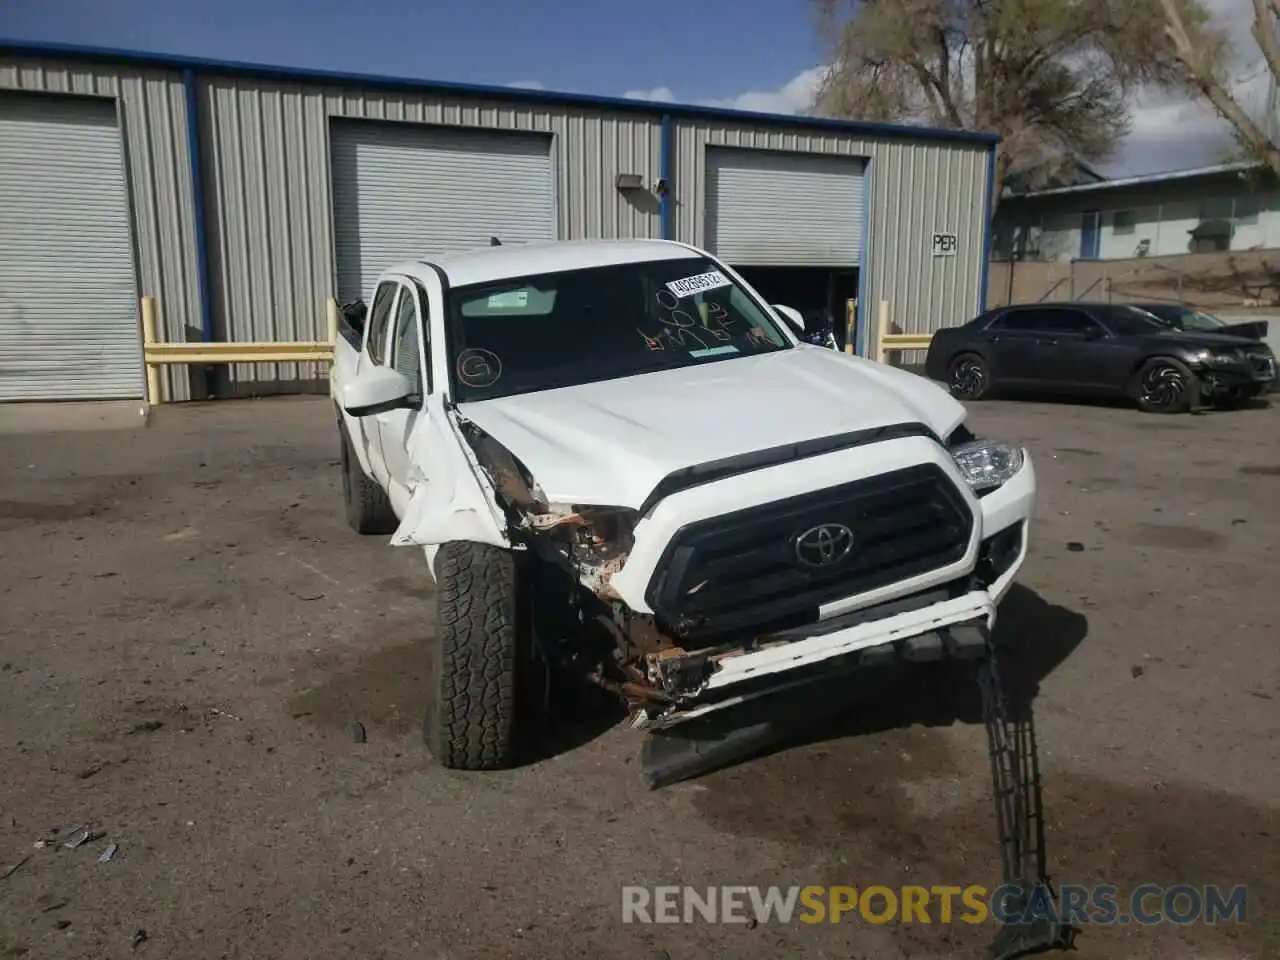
[0,398,1280,960]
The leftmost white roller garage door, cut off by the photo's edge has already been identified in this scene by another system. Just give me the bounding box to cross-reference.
[0,93,143,401]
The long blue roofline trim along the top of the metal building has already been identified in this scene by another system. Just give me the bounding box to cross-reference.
[0,38,1000,143]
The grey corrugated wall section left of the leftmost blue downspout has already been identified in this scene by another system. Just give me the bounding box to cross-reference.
[0,56,200,399]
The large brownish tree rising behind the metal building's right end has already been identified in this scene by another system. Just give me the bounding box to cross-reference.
[814,0,1182,197]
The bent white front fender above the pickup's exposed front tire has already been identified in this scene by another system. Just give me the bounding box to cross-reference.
[392,396,511,561]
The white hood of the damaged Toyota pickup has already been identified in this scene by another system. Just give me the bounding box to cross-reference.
[458,346,964,508]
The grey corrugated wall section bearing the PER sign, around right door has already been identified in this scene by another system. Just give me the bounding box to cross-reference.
[672,120,987,343]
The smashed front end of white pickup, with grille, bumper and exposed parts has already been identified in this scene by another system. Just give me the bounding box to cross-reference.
[458,417,1033,730]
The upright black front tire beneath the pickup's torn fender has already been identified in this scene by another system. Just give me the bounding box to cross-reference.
[422,541,532,771]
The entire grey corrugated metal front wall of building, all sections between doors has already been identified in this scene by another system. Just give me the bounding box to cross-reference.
[0,55,987,399]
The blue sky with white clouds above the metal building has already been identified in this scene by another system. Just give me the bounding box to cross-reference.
[0,0,1265,175]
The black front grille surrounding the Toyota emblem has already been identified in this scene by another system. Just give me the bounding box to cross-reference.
[646,463,974,640]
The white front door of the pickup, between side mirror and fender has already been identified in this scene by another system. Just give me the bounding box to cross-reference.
[371,280,430,517]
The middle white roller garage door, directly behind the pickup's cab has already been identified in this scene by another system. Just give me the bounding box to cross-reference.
[330,120,556,300]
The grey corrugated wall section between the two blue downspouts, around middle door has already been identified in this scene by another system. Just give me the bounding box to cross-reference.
[201,77,660,384]
